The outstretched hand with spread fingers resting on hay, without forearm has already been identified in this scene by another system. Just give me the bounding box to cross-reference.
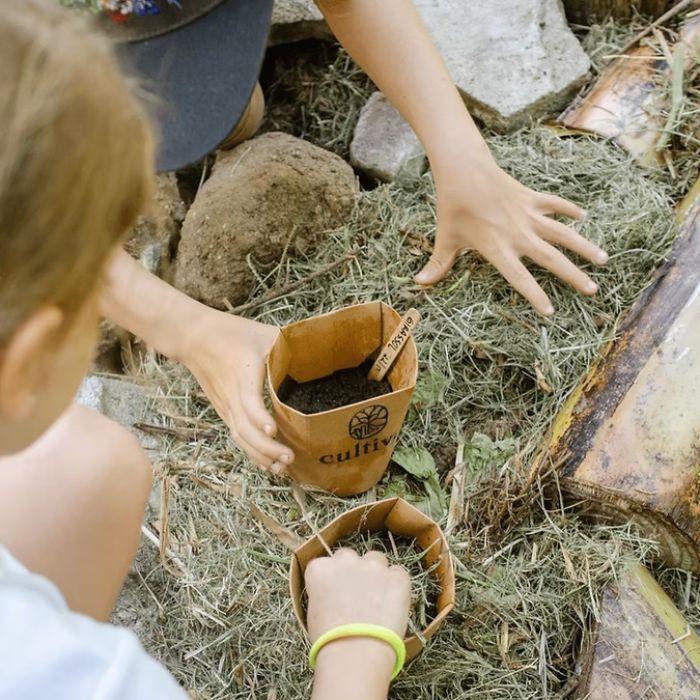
[416,159,608,316]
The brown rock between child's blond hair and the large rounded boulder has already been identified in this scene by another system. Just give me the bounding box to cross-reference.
[124,173,185,278]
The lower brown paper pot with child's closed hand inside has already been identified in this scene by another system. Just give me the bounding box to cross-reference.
[289,498,455,659]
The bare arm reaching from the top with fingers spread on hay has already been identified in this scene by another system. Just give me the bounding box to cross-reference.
[316,0,607,314]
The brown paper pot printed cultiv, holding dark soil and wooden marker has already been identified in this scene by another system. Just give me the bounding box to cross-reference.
[267,301,418,496]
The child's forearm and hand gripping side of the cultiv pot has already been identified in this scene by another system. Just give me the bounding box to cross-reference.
[102,250,293,473]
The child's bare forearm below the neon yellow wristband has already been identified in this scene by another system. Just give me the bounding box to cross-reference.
[312,637,396,700]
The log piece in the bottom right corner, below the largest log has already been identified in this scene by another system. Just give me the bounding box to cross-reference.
[575,563,700,700]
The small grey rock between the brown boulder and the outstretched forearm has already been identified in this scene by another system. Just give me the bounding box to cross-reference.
[350,92,426,182]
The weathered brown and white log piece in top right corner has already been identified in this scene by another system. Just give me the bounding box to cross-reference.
[558,16,700,166]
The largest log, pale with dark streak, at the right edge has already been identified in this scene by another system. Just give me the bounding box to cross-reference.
[534,183,700,572]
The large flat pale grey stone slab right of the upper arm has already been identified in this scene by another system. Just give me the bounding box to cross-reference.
[415,0,590,130]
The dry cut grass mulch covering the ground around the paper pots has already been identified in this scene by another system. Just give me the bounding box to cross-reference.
[120,15,700,700]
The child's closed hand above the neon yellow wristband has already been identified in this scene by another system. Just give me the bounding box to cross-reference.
[306,549,411,640]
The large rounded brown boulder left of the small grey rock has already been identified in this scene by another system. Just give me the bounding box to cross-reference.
[174,133,358,308]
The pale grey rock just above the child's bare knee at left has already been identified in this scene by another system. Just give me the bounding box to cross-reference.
[75,375,160,454]
